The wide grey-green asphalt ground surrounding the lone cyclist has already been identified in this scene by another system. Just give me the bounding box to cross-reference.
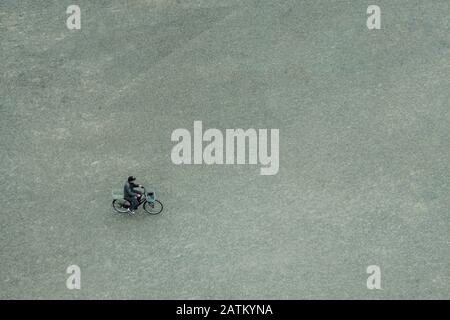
[0,0,450,299]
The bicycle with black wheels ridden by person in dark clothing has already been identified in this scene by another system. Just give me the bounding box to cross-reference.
[112,187,163,215]
